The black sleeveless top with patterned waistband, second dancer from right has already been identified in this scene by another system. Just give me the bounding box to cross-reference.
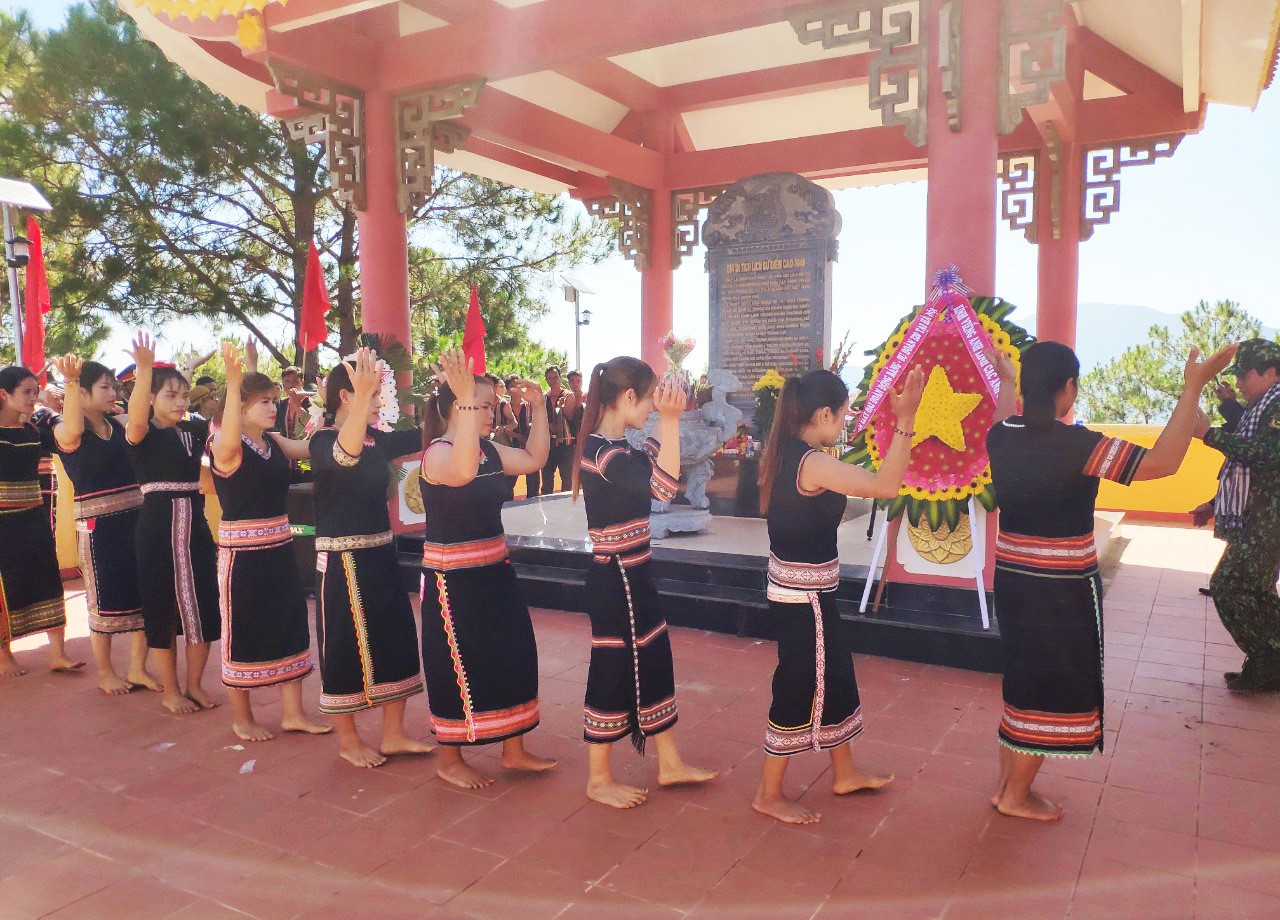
[767,438,849,591]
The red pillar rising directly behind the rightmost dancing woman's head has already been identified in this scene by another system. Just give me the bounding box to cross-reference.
[1036,25,1084,348]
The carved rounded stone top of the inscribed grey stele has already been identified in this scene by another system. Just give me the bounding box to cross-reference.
[703,173,840,248]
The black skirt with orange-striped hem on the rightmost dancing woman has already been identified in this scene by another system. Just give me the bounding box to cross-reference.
[995,568,1103,756]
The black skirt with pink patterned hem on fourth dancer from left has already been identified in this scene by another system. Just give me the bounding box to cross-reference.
[218,537,315,690]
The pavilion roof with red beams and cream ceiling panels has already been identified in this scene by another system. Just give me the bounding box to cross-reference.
[118,0,1280,194]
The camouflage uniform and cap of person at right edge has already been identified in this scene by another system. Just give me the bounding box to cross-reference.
[1204,339,1280,690]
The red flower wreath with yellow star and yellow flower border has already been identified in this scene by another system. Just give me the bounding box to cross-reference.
[841,297,1034,531]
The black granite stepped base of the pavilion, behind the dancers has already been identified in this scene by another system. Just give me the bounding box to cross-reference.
[401,537,1001,672]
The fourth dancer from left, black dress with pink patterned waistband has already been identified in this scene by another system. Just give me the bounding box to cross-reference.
[209,343,330,741]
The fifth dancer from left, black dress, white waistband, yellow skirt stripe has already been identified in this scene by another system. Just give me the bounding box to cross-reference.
[311,348,434,766]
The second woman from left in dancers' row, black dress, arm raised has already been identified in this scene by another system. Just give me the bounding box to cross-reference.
[54,354,161,696]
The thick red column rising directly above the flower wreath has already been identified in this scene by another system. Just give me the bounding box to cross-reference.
[922,0,1000,294]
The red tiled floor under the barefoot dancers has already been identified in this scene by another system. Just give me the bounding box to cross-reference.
[0,527,1280,920]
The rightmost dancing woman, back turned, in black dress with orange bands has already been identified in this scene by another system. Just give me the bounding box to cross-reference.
[987,342,1235,821]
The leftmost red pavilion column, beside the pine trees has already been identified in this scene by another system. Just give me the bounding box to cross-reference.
[356,92,412,351]
